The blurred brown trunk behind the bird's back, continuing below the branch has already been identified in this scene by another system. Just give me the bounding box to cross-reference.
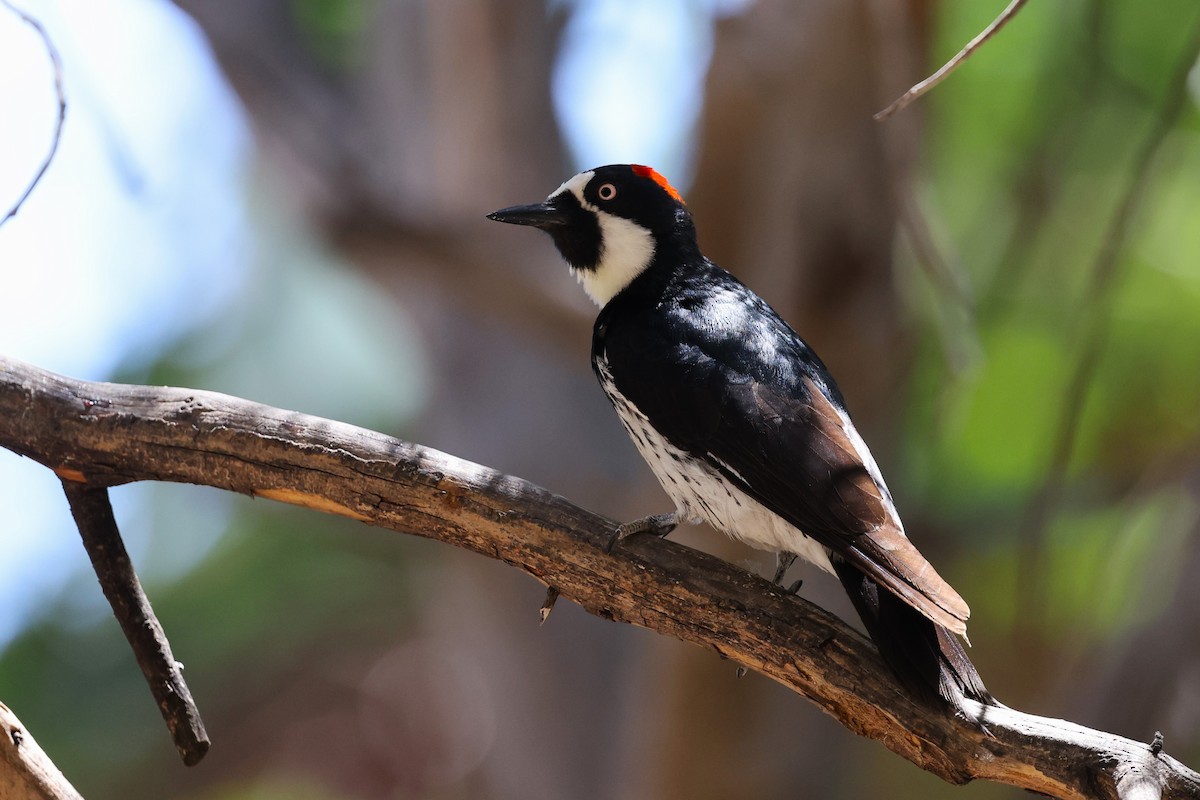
[628,0,923,800]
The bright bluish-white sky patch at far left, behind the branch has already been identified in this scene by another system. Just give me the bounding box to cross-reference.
[0,0,251,643]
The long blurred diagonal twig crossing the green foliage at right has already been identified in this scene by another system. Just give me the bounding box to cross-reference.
[1018,9,1200,642]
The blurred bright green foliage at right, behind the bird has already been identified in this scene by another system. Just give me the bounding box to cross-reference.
[905,0,1200,640]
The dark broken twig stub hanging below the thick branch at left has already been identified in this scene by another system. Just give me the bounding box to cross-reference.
[62,479,209,766]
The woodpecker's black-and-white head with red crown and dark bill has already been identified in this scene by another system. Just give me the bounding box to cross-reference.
[487,164,695,307]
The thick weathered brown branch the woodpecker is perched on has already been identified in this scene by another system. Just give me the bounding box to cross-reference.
[0,357,1200,799]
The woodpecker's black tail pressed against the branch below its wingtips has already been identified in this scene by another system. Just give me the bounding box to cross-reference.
[834,559,996,716]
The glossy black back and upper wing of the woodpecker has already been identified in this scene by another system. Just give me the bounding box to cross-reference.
[592,257,886,551]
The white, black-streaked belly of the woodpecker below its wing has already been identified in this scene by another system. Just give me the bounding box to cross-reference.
[599,362,833,573]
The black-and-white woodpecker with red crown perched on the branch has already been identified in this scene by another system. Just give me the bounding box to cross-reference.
[487,164,995,717]
